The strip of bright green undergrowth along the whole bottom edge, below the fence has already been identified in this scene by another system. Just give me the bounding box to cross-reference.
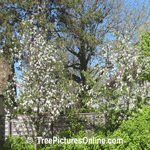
[2,107,150,150]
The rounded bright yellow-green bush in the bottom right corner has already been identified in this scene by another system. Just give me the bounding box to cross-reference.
[105,106,150,150]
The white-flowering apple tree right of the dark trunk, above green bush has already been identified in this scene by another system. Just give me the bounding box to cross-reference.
[81,29,150,131]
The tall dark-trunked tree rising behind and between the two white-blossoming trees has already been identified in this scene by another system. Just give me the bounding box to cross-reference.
[51,1,149,109]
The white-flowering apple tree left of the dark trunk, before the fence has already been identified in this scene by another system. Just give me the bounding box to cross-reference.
[5,17,78,149]
